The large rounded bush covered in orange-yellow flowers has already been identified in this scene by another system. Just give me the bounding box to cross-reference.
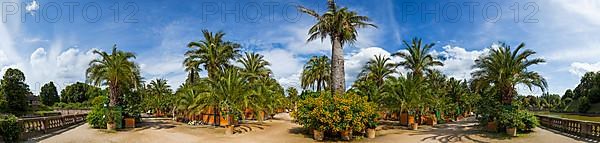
[292,92,378,132]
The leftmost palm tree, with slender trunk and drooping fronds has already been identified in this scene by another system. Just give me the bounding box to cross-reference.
[86,44,140,129]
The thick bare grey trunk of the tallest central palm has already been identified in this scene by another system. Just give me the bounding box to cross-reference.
[331,36,346,94]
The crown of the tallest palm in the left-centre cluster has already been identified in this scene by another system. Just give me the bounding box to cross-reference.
[189,30,240,78]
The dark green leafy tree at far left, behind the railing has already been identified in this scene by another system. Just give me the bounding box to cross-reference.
[0,68,30,115]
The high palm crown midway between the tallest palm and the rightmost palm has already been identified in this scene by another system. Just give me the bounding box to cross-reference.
[392,38,444,77]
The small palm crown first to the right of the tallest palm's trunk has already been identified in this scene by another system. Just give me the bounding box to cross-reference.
[358,55,398,85]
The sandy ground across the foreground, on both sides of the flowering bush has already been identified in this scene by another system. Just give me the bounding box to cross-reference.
[39,114,583,143]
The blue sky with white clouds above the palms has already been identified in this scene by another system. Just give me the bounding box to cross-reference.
[0,0,600,94]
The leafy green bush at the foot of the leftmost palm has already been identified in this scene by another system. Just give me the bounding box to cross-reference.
[87,96,123,129]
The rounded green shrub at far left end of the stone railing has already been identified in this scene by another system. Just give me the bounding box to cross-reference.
[0,115,21,143]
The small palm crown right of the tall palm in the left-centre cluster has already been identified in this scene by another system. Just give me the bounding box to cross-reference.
[238,53,271,81]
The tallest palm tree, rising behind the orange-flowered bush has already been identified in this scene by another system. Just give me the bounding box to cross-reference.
[298,0,377,94]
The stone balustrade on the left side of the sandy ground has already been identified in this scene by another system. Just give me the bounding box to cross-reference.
[18,113,87,138]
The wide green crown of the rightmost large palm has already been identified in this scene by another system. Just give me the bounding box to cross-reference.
[471,43,548,104]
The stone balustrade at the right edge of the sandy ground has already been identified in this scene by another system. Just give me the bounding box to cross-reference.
[535,115,600,140]
